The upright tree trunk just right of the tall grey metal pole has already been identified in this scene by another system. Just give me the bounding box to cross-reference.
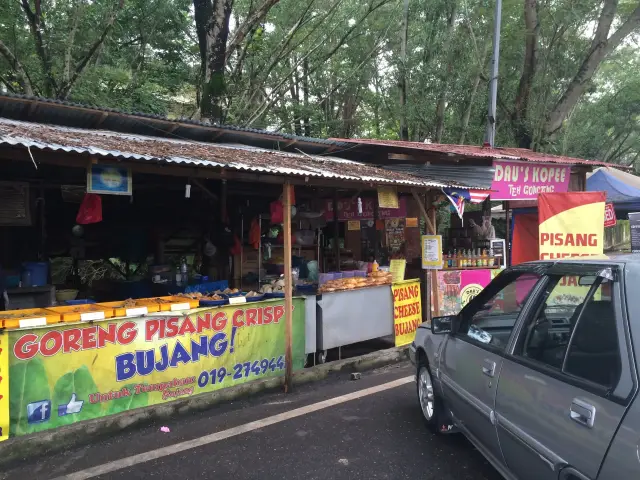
[511,0,540,148]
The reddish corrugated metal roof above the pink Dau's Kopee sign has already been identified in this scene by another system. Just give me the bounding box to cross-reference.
[330,138,629,169]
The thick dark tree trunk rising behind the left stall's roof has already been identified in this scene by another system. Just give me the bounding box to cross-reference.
[193,0,233,123]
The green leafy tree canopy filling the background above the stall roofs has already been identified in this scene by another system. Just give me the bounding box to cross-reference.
[0,0,640,165]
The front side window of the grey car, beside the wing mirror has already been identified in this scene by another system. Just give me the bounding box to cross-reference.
[458,273,540,350]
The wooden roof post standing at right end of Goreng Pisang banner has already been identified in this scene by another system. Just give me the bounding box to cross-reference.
[282,181,293,393]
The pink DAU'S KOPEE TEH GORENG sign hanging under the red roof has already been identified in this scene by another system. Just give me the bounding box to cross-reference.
[491,160,571,200]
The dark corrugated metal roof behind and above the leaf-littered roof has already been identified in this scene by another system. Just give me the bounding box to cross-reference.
[0,93,352,153]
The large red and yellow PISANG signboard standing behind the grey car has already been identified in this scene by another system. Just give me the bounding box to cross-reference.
[538,192,606,260]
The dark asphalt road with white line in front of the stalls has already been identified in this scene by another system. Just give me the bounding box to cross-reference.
[0,365,501,480]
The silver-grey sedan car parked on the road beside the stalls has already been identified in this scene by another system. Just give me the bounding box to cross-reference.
[410,256,640,480]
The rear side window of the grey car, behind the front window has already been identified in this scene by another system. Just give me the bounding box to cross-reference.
[514,275,621,387]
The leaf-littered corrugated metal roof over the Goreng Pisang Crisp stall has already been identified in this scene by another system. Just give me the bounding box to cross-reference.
[0,118,484,188]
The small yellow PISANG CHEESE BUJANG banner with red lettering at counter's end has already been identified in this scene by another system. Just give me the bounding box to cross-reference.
[391,280,422,347]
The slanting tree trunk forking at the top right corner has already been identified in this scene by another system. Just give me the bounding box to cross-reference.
[544,0,640,137]
